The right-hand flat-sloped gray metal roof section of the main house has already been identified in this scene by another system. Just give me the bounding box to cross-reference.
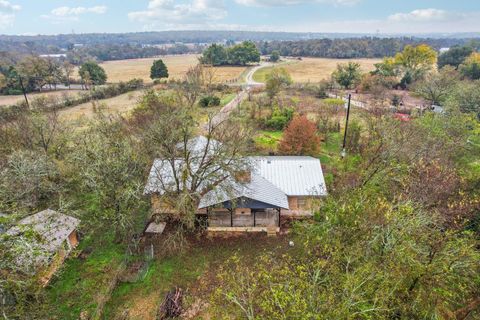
[251,156,327,196]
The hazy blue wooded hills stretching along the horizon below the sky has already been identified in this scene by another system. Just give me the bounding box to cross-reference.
[0,31,480,64]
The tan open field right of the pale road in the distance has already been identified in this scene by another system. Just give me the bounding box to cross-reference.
[253,58,381,82]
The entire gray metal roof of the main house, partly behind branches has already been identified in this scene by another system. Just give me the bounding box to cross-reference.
[144,136,327,209]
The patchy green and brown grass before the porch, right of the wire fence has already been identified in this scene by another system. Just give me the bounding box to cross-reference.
[104,235,287,319]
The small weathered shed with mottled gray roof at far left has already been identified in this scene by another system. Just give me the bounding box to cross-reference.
[6,209,80,285]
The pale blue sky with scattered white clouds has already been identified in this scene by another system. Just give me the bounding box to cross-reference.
[0,0,480,35]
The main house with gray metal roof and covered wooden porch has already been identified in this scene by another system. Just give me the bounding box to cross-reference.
[144,138,327,232]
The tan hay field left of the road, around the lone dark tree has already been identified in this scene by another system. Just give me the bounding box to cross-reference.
[101,54,246,82]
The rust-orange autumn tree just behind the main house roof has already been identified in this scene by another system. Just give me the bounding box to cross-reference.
[278,116,320,155]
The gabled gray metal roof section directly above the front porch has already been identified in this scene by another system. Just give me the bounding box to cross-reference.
[198,173,289,209]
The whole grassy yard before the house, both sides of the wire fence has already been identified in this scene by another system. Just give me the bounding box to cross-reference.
[48,234,291,319]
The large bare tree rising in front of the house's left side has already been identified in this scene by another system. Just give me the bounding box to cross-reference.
[142,101,251,228]
